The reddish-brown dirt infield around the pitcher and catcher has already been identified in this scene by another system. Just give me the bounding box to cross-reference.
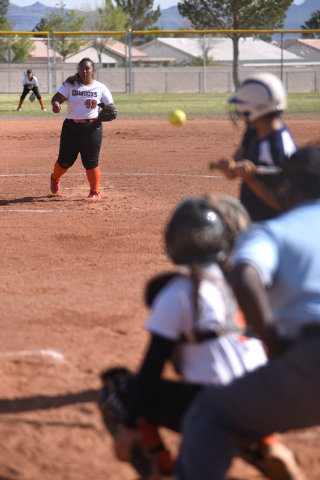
[0,117,320,480]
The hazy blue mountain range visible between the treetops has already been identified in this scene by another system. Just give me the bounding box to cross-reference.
[8,0,320,31]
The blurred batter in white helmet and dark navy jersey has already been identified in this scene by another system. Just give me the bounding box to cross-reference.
[215,73,296,221]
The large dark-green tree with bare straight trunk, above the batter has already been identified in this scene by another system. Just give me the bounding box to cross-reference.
[178,0,293,88]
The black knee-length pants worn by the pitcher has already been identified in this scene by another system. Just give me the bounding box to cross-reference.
[58,118,102,170]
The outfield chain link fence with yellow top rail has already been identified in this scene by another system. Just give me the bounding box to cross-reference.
[0,30,320,94]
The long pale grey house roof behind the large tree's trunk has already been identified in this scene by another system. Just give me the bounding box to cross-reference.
[139,37,301,62]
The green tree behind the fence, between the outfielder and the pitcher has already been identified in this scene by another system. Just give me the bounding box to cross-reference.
[34,0,86,61]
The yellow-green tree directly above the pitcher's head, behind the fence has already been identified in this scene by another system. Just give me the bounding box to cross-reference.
[84,0,130,62]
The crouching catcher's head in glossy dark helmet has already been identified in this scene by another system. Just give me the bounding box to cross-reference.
[165,195,250,265]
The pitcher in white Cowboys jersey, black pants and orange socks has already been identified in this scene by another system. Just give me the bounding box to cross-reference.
[50,58,114,200]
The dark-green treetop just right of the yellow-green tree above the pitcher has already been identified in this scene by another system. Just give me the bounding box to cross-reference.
[115,0,161,45]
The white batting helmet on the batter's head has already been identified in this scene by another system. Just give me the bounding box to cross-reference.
[229,73,286,122]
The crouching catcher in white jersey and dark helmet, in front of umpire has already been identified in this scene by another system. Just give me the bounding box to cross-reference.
[100,196,302,480]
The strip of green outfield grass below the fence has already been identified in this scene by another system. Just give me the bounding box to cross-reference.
[0,92,320,119]
